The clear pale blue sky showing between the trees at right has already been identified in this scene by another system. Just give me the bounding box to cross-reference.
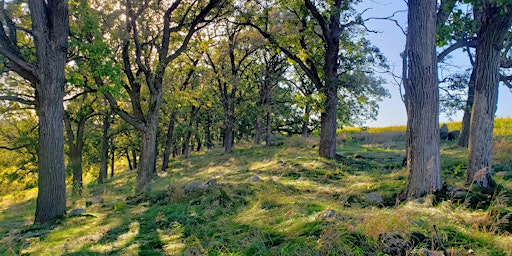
[356,0,512,127]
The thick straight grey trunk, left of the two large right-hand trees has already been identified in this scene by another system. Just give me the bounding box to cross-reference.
[403,0,442,198]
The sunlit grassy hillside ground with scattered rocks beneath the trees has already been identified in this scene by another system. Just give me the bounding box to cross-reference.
[0,120,512,255]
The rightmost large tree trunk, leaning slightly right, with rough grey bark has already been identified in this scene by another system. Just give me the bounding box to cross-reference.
[466,0,512,187]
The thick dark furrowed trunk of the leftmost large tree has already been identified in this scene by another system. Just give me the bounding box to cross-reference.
[29,0,69,223]
